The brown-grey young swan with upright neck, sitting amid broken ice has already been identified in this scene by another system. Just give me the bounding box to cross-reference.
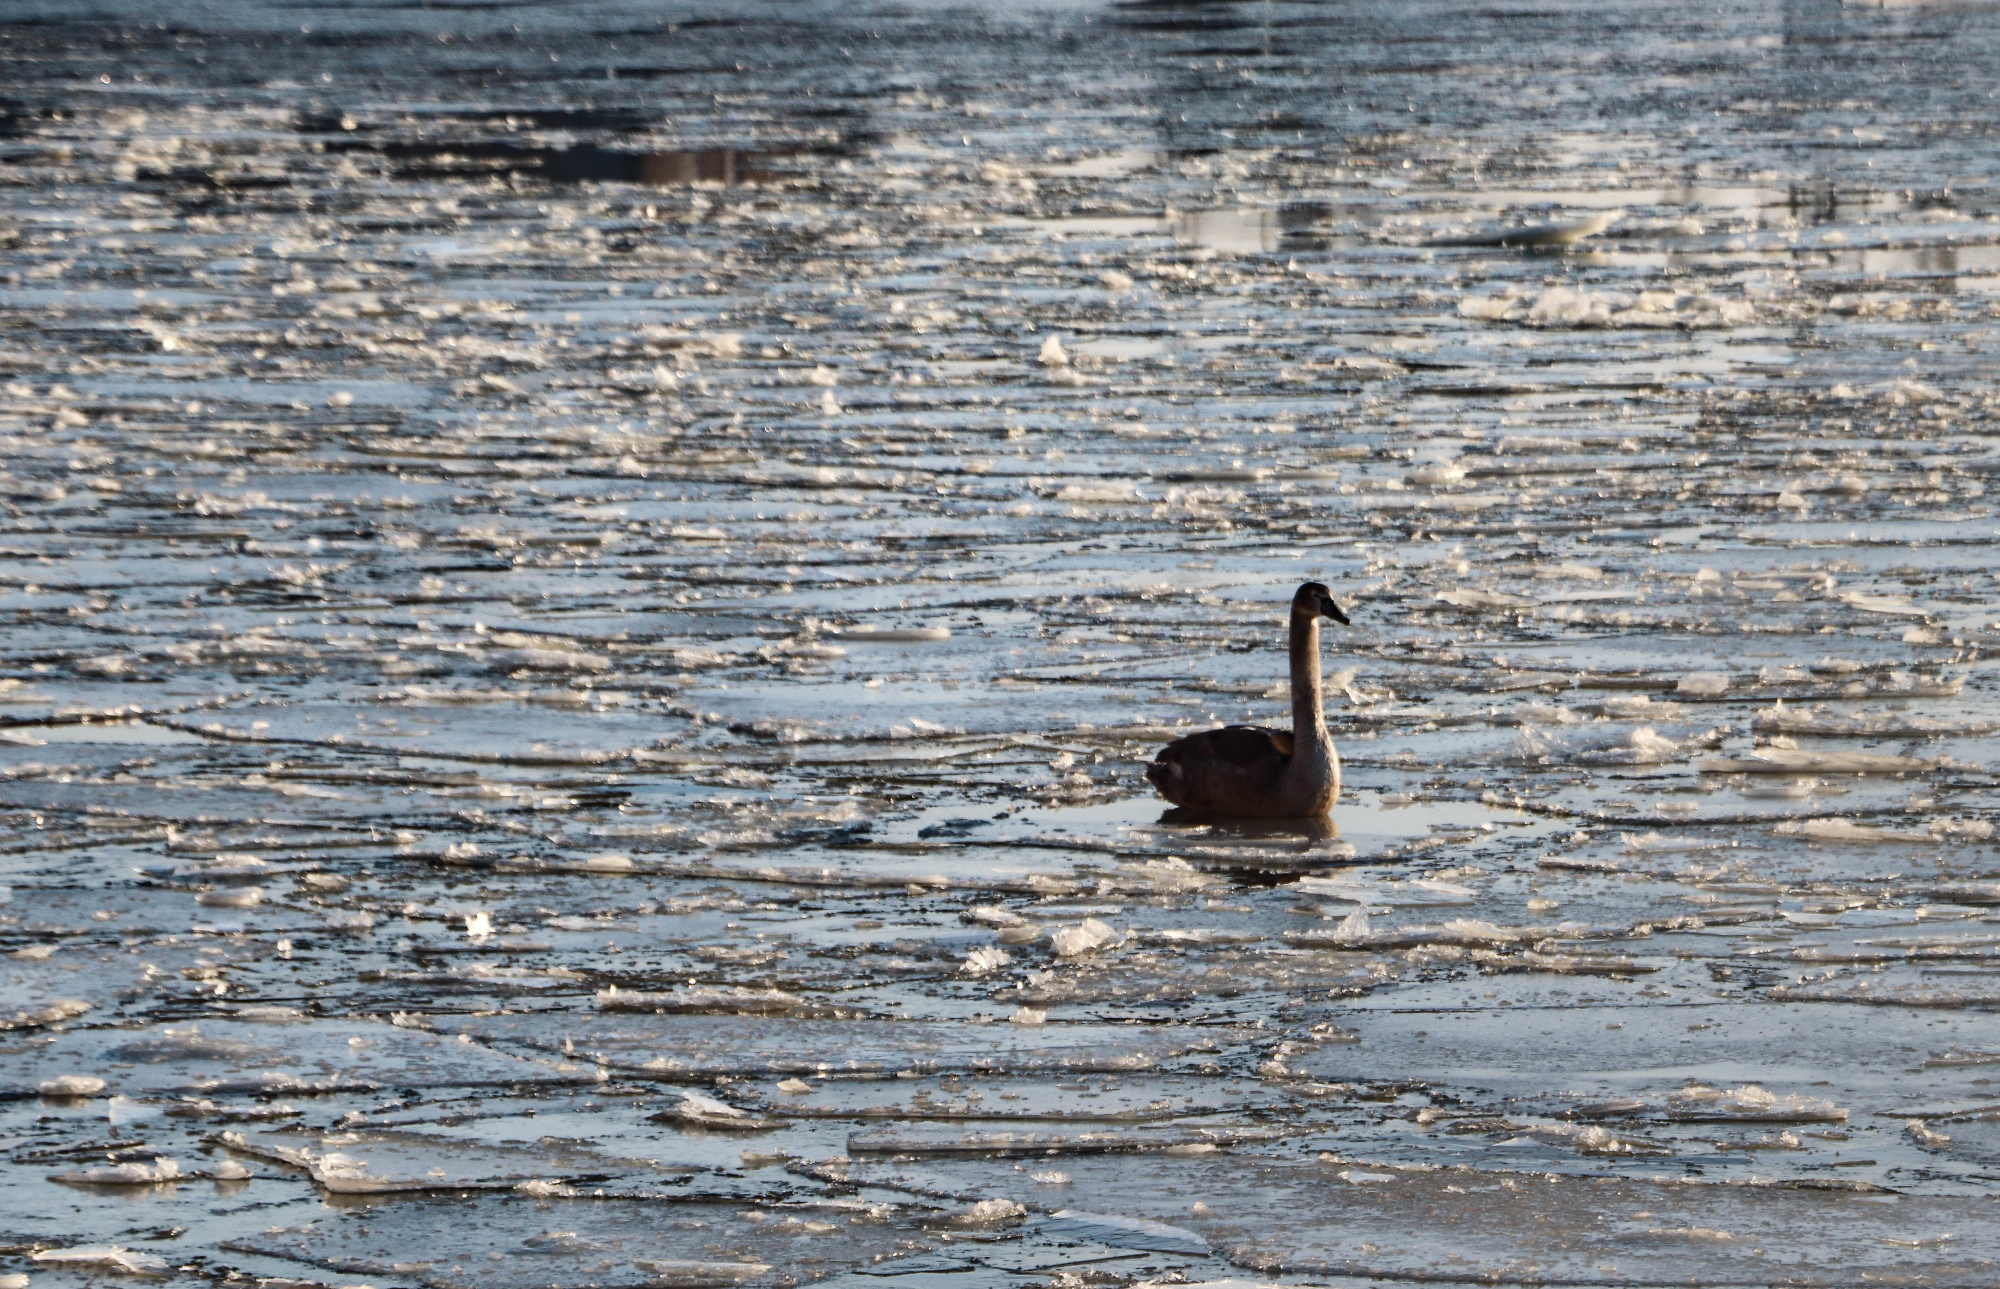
[1146,582,1348,819]
